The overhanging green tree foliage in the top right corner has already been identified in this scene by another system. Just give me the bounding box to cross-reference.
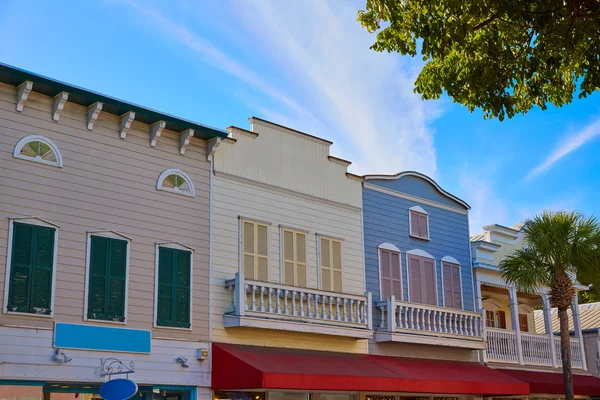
[358,0,600,120]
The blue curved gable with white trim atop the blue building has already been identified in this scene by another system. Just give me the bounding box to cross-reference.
[367,173,469,210]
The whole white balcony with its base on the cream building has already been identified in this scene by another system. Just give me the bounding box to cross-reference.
[223,273,373,339]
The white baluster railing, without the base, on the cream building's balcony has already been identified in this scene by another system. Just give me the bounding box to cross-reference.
[225,273,372,329]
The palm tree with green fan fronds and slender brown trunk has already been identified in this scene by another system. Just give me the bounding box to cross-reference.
[499,211,600,400]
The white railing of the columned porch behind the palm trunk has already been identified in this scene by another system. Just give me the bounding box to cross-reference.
[486,328,584,369]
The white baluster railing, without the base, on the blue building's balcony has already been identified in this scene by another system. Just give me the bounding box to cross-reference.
[376,296,483,339]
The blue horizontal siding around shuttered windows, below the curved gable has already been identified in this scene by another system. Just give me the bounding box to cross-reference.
[363,184,474,311]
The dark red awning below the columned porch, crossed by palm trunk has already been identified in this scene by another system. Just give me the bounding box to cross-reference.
[499,369,600,396]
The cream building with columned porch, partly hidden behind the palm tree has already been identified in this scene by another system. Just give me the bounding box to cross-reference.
[471,224,594,396]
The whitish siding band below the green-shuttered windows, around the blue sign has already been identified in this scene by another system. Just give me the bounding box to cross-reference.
[0,327,210,387]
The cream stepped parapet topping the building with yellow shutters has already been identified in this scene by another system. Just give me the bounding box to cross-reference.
[215,119,362,207]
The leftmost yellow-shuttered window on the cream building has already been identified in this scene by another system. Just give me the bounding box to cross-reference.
[242,220,269,281]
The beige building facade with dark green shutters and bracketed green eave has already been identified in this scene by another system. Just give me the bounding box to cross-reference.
[0,65,227,399]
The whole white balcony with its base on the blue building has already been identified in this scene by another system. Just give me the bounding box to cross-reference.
[375,296,486,349]
